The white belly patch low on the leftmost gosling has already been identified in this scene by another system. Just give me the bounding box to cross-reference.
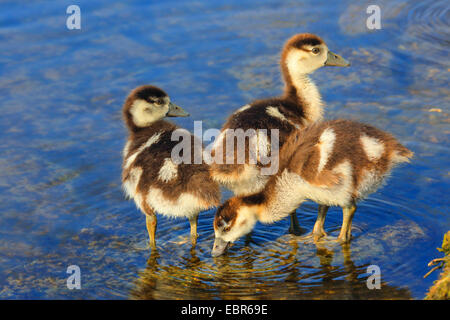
[145,187,213,218]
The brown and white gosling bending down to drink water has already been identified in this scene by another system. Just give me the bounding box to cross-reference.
[212,120,413,256]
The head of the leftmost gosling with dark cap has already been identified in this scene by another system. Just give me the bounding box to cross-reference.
[123,85,189,129]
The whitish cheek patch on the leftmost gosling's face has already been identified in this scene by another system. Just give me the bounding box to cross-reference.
[130,99,169,127]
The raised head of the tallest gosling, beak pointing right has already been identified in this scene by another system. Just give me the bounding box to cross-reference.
[281,33,350,77]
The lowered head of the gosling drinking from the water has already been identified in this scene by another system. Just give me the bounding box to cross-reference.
[211,197,258,257]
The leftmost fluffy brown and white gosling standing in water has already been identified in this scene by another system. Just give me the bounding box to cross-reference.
[122,85,220,248]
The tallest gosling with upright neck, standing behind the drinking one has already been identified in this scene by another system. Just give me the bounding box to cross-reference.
[211,33,350,232]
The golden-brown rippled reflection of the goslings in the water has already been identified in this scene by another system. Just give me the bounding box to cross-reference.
[130,240,411,299]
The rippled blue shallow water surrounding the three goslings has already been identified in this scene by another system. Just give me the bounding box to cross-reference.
[0,0,450,299]
